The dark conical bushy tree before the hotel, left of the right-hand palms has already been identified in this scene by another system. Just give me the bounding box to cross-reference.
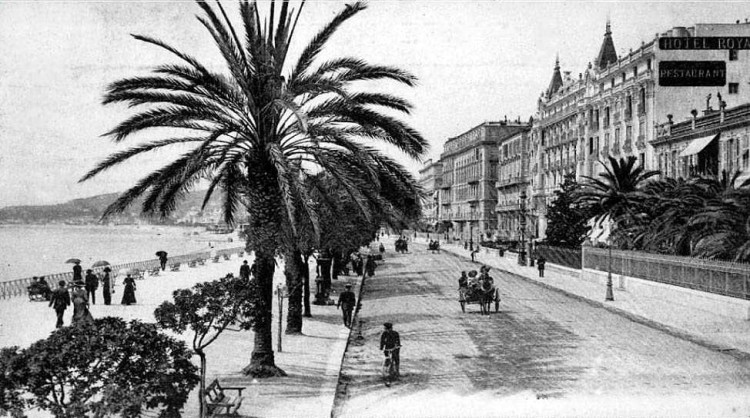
[547,174,592,247]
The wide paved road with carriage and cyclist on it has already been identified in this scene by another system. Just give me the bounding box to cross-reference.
[334,245,750,417]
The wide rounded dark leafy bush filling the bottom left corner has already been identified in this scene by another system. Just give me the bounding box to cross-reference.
[0,317,198,418]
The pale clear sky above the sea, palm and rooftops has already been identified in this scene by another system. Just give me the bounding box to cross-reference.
[0,0,750,207]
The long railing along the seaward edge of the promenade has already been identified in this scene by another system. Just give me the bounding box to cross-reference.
[0,247,245,299]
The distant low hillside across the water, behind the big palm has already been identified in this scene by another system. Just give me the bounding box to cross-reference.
[0,190,228,224]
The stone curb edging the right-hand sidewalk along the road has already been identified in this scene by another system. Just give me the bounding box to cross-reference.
[438,242,750,360]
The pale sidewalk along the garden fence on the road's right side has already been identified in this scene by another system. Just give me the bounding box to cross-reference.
[432,239,750,358]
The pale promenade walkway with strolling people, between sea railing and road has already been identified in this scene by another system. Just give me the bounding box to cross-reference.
[0,247,359,417]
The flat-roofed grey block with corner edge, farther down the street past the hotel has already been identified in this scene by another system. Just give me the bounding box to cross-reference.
[439,121,529,242]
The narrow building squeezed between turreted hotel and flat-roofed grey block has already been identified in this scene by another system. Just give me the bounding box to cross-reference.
[495,129,536,240]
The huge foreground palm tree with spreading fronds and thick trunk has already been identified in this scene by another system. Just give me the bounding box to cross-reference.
[81,0,427,376]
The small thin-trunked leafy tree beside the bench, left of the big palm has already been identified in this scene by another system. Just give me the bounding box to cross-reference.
[154,275,254,417]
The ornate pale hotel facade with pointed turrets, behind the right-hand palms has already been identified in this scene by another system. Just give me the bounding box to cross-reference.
[530,22,750,238]
